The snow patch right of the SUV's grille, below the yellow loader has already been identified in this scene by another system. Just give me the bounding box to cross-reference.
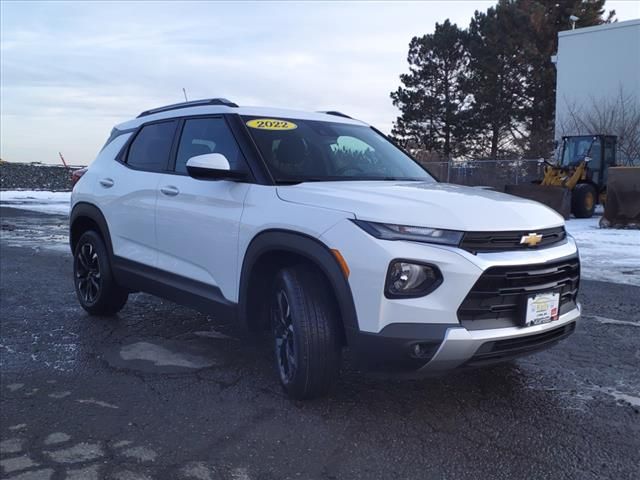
[566,217,640,286]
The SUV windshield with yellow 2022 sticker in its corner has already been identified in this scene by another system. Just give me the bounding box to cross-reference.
[243,116,435,183]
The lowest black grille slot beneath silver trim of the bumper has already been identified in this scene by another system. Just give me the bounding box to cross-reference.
[467,322,576,366]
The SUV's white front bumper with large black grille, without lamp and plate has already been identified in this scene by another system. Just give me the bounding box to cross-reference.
[321,220,580,372]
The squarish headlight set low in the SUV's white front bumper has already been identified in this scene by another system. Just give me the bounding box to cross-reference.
[384,260,442,298]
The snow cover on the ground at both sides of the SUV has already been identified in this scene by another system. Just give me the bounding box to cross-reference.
[0,190,640,286]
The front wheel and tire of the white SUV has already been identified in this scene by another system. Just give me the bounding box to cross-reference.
[270,265,342,400]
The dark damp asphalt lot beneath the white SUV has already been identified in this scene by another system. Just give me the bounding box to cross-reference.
[0,208,640,480]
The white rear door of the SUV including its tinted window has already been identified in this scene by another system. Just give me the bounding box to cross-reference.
[102,120,178,266]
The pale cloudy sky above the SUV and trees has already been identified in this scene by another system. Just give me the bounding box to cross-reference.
[0,0,640,165]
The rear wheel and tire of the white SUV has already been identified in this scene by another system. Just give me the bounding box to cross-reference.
[73,230,129,316]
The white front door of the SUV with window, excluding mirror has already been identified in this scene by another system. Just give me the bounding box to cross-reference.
[156,116,250,301]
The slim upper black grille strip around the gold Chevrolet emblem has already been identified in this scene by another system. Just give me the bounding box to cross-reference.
[460,227,567,254]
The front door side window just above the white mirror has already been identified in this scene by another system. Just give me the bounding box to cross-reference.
[176,118,245,173]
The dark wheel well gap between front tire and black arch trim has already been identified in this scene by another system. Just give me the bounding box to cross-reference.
[247,250,347,345]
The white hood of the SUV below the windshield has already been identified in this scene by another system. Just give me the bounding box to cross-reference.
[278,181,564,231]
